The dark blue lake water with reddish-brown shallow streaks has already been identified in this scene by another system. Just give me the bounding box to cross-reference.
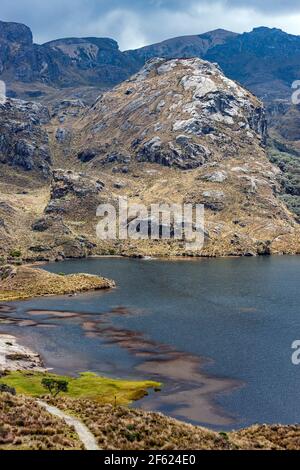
[0,257,300,429]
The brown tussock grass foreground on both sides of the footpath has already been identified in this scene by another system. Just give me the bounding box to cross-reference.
[0,393,300,450]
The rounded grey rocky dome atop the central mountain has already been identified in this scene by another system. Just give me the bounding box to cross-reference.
[76,58,266,169]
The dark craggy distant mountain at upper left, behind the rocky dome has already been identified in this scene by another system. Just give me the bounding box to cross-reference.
[0,21,137,98]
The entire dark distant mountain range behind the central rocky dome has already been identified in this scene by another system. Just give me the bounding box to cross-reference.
[0,22,300,104]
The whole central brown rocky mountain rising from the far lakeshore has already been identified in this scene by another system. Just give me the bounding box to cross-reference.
[0,59,300,260]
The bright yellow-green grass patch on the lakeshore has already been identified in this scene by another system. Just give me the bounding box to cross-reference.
[0,371,161,405]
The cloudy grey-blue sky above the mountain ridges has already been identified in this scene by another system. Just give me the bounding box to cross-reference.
[0,0,300,50]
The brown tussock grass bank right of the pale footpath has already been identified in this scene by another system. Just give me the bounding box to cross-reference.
[45,397,300,450]
